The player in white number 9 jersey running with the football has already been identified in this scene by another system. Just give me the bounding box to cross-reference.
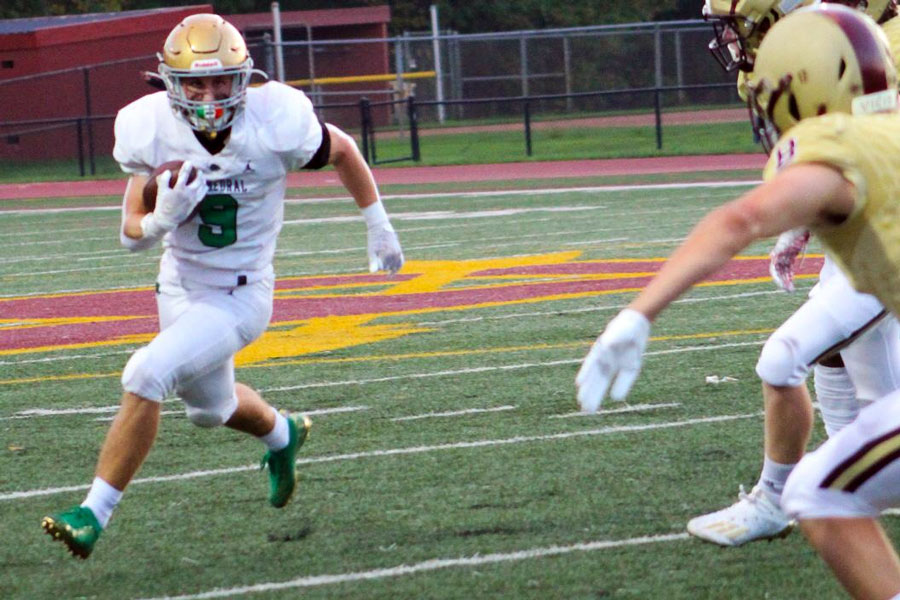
[42,14,403,558]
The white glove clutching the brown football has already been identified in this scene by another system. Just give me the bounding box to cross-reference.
[141,160,209,238]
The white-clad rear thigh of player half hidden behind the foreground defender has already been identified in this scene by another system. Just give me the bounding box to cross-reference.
[841,315,900,402]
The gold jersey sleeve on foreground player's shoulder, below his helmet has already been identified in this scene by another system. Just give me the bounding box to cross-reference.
[763,114,867,216]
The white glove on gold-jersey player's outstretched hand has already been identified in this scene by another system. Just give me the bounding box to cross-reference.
[575,308,650,413]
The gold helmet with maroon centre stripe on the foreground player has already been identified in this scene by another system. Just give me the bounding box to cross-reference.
[747,4,898,152]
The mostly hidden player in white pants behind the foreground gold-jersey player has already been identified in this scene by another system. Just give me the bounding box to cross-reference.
[687,0,900,546]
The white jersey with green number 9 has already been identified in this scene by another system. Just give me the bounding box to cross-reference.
[113,82,322,287]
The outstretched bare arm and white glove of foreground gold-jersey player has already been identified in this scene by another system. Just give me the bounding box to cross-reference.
[575,164,856,412]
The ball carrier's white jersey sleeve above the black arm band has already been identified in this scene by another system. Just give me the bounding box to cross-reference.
[260,81,323,167]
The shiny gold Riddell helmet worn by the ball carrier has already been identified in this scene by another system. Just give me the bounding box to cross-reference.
[157,14,255,135]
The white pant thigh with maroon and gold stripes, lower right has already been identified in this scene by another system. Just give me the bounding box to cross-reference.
[782,392,900,519]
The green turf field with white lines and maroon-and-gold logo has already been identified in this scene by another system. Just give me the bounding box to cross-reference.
[0,183,860,600]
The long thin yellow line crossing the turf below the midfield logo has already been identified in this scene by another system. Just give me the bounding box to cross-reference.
[0,328,774,385]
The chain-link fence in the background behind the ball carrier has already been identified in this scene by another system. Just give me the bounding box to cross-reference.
[0,20,739,173]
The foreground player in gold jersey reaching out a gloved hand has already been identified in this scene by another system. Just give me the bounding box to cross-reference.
[575,4,900,599]
